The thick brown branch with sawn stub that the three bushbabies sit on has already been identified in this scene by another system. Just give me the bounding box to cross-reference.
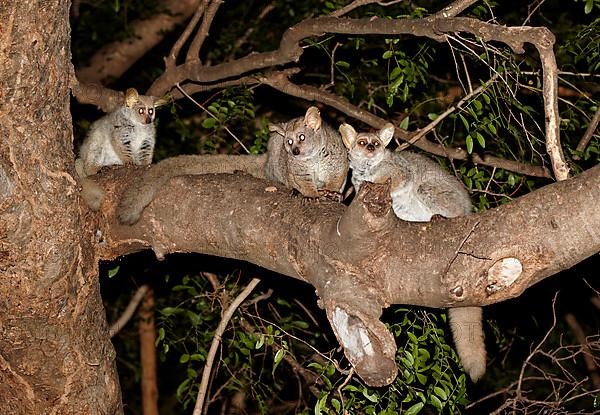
[86,161,600,386]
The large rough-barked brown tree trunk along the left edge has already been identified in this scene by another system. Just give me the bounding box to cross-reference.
[0,0,122,415]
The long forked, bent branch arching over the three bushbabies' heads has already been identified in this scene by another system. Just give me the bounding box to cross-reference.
[75,0,569,180]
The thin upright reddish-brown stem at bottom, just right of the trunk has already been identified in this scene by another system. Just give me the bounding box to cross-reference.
[138,289,158,415]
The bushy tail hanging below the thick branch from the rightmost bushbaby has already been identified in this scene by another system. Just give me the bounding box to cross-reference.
[448,307,486,382]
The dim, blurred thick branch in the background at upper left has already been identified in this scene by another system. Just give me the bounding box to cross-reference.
[77,0,199,84]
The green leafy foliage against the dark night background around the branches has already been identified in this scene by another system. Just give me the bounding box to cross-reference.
[73,0,600,414]
